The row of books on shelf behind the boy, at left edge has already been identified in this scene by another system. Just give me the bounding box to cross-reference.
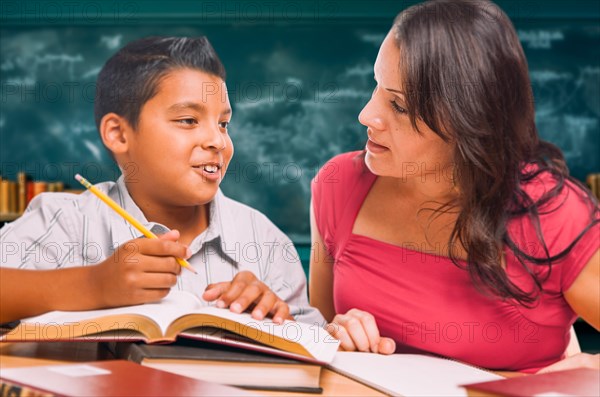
[0,172,64,220]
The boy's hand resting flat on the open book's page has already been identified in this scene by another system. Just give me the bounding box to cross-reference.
[202,270,293,324]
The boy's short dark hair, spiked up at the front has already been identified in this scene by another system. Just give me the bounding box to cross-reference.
[94,36,225,130]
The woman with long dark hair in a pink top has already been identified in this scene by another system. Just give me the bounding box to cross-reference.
[310,0,600,372]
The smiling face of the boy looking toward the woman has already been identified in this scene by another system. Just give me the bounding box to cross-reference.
[122,69,233,206]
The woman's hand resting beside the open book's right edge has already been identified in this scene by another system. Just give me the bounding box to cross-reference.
[327,309,396,354]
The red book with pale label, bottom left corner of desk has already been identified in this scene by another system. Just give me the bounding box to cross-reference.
[0,360,251,397]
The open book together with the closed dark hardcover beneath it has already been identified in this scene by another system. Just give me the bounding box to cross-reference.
[0,291,342,393]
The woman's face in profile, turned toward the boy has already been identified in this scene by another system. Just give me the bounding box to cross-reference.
[358,32,452,182]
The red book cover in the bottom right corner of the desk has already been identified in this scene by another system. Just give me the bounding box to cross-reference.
[462,368,600,396]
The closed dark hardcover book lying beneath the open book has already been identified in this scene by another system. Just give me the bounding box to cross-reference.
[112,340,323,393]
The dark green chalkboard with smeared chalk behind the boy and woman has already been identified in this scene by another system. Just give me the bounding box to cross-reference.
[0,2,600,242]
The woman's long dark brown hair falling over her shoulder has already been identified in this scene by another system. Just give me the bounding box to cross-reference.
[392,0,599,306]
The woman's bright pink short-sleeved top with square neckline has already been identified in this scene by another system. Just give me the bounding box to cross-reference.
[312,152,600,372]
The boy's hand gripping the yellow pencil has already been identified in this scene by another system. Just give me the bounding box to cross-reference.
[90,230,190,307]
